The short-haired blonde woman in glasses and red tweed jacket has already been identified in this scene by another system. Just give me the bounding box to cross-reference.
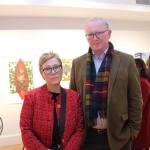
[20,52,84,150]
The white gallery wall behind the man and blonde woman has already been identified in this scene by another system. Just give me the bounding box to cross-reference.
[0,17,150,147]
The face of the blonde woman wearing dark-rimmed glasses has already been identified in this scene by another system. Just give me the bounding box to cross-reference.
[41,58,63,86]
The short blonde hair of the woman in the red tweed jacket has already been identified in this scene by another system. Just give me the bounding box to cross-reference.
[39,52,62,72]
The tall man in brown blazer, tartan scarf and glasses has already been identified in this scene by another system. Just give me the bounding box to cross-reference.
[70,18,142,150]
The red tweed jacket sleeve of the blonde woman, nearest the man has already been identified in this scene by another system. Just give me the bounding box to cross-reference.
[64,94,84,150]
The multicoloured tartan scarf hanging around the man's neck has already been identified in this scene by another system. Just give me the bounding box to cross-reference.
[85,45,114,122]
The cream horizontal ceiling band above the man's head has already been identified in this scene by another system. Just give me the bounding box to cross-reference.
[0,5,150,22]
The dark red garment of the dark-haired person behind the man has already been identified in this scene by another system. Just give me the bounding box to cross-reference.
[132,78,150,149]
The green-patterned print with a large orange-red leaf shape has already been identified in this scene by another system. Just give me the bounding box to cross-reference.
[9,59,33,100]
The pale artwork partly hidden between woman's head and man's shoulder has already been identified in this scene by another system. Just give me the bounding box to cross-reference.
[62,59,73,81]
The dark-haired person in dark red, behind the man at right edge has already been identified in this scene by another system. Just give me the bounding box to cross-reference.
[132,58,150,150]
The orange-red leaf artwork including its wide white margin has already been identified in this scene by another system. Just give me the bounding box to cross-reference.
[0,55,34,104]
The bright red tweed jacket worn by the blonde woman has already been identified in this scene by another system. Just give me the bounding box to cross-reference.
[20,85,84,150]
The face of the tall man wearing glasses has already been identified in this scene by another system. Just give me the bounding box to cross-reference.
[85,20,111,53]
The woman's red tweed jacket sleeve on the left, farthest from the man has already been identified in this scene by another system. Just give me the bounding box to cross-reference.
[20,94,47,150]
